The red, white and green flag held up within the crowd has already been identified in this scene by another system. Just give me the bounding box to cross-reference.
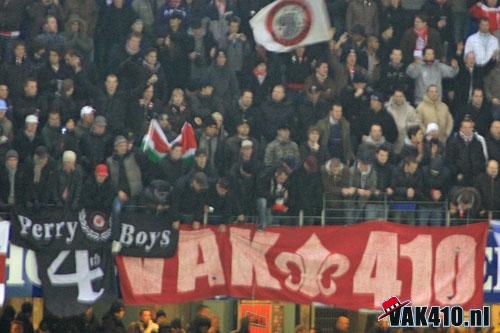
[142,119,198,162]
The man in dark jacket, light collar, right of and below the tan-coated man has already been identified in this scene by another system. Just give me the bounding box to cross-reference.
[446,118,486,186]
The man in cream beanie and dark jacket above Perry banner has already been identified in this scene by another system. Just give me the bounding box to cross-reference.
[51,150,83,211]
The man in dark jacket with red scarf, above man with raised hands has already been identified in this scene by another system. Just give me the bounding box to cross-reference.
[401,12,443,64]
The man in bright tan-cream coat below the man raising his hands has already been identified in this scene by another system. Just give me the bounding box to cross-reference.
[417,85,453,143]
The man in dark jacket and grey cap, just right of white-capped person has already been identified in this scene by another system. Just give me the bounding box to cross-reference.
[80,116,113,172]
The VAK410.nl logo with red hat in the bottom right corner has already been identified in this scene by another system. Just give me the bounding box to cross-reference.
[378,296,491,327]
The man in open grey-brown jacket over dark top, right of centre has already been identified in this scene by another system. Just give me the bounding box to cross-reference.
[316,103,354,165]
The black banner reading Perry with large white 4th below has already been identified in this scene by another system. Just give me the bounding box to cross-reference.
[12,209,117,317]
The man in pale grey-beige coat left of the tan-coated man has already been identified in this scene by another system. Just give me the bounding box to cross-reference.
[385,89,419,154]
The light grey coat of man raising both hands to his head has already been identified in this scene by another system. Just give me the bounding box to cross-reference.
[406,61,458,104]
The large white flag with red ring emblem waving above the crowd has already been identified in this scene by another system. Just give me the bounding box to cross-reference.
[250,0,333,52]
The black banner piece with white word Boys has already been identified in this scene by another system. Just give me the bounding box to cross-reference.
[120,212,179,258]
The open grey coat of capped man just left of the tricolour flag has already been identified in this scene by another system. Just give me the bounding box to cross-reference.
[106,153,143,197]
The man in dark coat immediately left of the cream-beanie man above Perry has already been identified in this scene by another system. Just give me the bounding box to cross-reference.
[24,146,56,208]
